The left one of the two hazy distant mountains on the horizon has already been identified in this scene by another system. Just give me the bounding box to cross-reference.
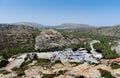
[13,22,46,28]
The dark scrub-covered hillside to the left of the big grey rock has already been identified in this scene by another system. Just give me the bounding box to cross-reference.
[0,24,39,52]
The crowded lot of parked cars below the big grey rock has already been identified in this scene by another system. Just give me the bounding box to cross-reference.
[51,48,99,63]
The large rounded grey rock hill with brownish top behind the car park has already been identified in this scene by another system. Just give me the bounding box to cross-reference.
[35,29,74,50]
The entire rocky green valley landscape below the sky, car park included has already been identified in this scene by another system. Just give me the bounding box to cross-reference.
[0,23,120,78]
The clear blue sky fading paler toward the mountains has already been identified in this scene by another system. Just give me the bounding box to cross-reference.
[0,0,120,26]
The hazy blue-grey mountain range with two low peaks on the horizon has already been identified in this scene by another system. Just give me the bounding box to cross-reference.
[13,22,93,29]
